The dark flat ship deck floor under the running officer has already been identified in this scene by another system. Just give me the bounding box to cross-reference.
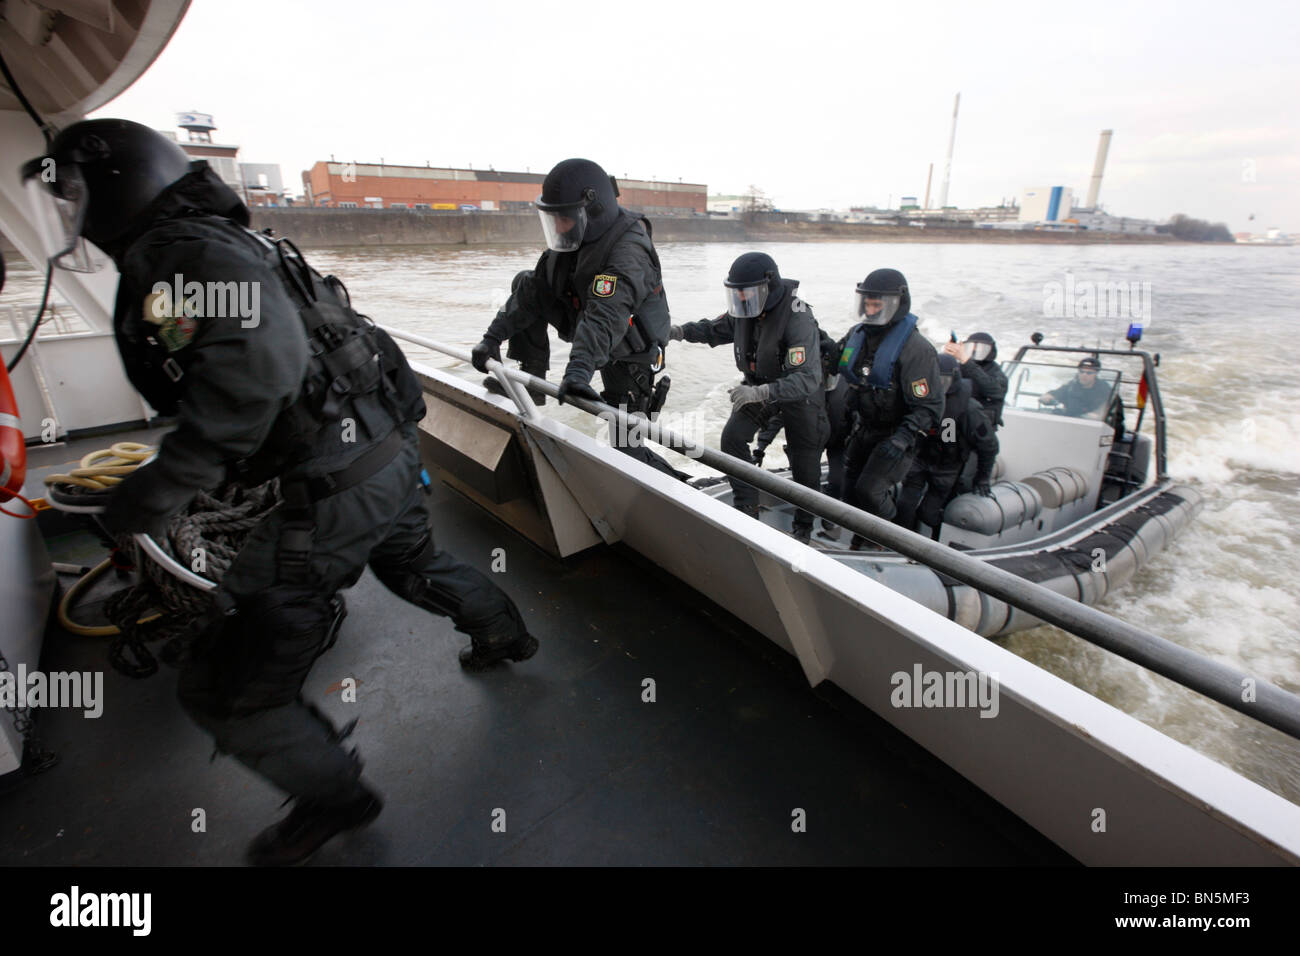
[0,431,1074,866]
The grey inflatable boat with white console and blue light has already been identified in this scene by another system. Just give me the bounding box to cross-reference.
[697,332,1201,637]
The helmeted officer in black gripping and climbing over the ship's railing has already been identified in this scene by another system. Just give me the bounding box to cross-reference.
[472,159,684,477]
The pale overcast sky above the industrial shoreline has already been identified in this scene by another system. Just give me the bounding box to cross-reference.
[96,0,1300,233]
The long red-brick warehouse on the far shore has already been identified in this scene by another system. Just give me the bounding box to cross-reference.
[303,161,709,216]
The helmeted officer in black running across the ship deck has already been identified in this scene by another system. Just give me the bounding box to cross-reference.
[23,120,537,864]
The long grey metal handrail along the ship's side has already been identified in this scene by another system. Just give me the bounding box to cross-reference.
[381,326,1300,740]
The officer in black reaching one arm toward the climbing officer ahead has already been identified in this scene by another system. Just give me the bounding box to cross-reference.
[671,252,831,544]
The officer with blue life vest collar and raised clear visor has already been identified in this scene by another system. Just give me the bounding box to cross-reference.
[839,269,944,548]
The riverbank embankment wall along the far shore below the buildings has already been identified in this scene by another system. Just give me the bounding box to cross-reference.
[245,208,1178,248]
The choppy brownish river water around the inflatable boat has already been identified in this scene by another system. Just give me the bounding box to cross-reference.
[4,243,1300,803]
